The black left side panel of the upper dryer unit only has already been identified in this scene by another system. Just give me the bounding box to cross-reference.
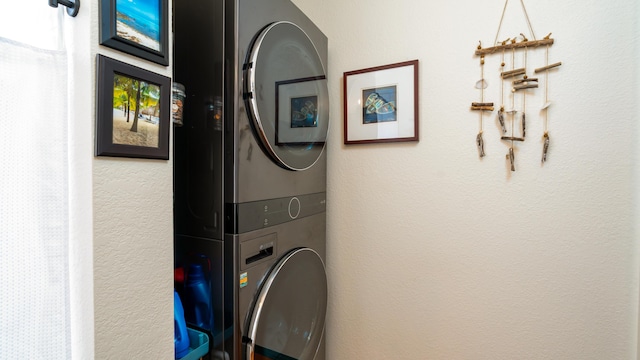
[173,0,225,240]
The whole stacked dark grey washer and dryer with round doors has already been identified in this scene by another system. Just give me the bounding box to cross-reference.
[173,0,329,360]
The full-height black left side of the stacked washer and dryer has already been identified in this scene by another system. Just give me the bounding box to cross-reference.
[173,0,229,360]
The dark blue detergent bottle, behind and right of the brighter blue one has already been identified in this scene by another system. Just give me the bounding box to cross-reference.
[185,264,213,331]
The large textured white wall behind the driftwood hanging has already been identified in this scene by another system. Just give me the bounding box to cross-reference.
[294,0,640,360]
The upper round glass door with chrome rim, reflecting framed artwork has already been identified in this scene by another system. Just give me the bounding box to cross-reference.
[243,21,329,170]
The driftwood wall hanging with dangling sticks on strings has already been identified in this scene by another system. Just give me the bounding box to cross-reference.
[471,0,562,171]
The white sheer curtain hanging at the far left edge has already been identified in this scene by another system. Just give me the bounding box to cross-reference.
[0,0,71,359]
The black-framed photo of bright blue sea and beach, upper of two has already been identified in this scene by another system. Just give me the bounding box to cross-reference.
[100,0,169,66]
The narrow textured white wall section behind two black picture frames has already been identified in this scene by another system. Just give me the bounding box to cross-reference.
[89,0,174,359]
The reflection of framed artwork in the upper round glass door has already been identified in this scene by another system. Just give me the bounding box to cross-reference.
[276,76,329,145]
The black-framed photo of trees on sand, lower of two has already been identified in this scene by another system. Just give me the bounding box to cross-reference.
[96,55,171,160]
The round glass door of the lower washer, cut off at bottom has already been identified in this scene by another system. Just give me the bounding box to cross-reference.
[245,248,327,360]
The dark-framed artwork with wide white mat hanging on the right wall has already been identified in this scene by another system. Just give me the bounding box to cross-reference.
[343,60,418,144]
